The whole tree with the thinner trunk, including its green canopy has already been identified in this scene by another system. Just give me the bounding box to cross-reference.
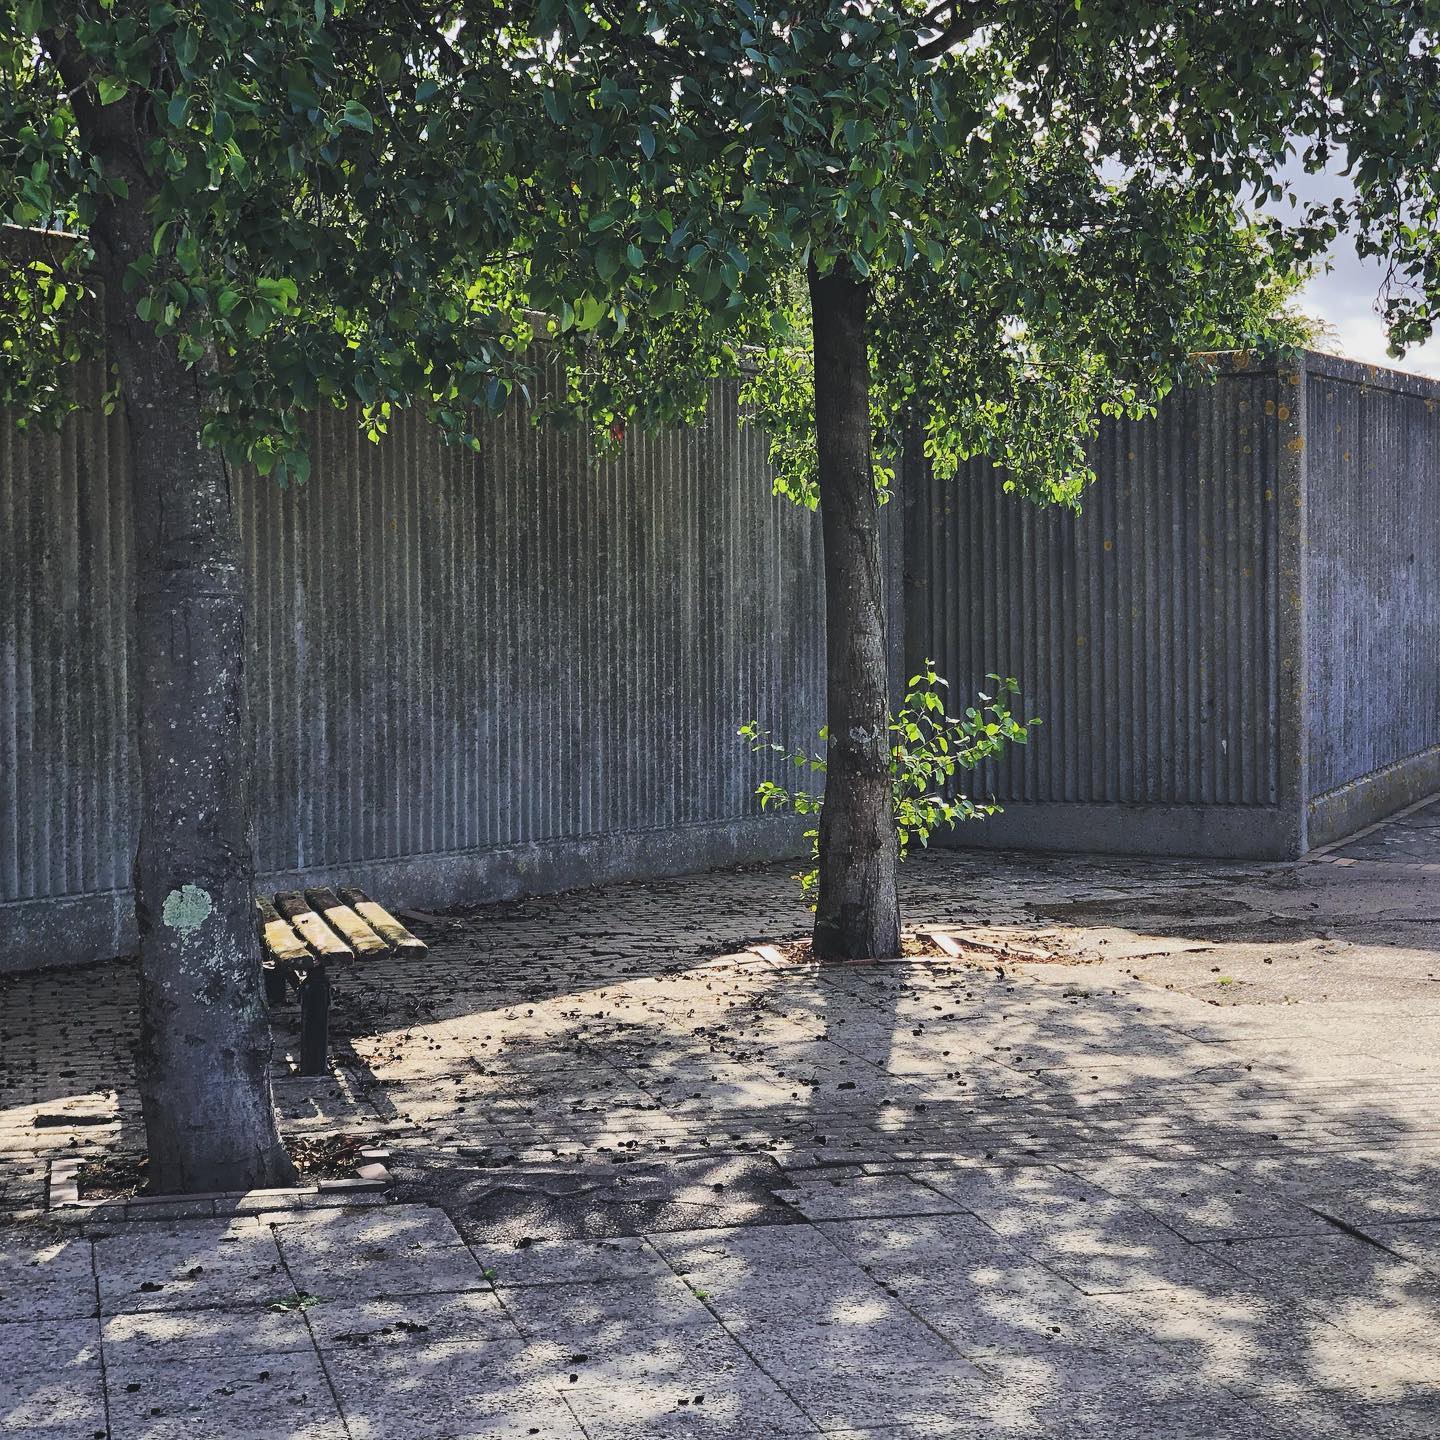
[527,0,1440,958]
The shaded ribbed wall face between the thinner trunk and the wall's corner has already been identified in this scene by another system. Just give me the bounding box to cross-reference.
[906,355,1302,855]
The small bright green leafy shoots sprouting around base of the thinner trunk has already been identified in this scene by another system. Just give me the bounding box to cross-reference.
[739,660,1040,906]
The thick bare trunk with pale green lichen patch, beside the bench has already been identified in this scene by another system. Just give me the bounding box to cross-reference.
[67,75,295,1194]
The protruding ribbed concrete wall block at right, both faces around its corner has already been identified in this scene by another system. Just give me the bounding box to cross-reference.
[906,354,1440,858]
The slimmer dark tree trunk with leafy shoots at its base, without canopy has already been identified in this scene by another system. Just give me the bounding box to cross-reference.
[809,266,900,959]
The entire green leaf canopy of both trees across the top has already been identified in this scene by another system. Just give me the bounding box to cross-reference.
[0,0,1440,503]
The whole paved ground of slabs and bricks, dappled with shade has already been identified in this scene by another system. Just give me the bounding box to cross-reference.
[0,805,1440,1440]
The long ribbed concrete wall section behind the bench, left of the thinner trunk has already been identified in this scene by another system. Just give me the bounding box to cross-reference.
[0,354,822,965]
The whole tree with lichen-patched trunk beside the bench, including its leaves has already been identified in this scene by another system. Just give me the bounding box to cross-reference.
[0,0,541,1191]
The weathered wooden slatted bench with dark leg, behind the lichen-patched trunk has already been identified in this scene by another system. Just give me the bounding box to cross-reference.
[255,886,426,1076]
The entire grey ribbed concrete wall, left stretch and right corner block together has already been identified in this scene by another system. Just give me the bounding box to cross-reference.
[0,356,1440,963]
